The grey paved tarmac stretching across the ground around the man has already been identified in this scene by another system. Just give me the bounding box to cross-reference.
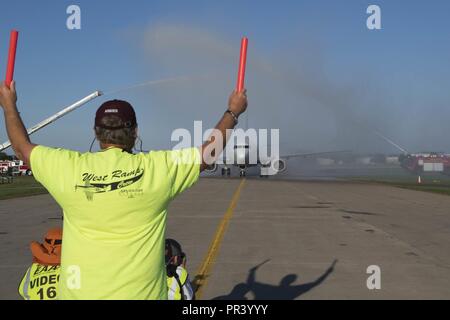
[0,178,450,300]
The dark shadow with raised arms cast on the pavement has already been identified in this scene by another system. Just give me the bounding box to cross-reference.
[213,260,337,300]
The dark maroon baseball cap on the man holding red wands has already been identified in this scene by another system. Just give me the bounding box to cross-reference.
[95,100,137,130]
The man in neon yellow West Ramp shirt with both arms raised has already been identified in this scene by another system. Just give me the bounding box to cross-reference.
[0,82,247,299]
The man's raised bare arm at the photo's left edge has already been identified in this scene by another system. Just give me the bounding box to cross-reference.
[0,81,35,165]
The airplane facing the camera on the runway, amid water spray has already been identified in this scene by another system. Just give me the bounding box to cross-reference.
[205,143,350,178]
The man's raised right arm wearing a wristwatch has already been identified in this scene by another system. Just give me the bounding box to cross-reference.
[200,90,247,171]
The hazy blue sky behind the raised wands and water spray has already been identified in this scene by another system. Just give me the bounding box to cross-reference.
[0,0,450,152]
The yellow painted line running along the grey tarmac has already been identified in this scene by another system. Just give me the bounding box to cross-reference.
[194,179,246,300]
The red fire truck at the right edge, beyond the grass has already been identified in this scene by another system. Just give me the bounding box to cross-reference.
[399,152,450,175]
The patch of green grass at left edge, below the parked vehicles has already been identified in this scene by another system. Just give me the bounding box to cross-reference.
[0,177,47,200]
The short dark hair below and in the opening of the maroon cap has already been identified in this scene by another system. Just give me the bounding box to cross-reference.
[95,115,137,149]
